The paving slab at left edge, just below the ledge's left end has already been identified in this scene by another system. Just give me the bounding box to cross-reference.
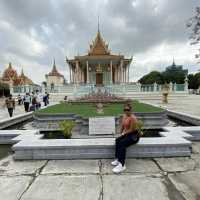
[0,156,46,176]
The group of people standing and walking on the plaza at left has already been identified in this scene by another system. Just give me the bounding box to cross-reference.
[5,91,49,117]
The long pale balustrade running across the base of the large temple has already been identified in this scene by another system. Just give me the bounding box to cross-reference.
[11,83,188,97]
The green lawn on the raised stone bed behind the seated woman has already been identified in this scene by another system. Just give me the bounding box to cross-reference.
[37,101,163,117]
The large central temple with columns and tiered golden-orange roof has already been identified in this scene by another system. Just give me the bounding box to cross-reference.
[66,29,132,86]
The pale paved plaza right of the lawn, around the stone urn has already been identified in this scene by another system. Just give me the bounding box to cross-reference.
[143,95,200,117]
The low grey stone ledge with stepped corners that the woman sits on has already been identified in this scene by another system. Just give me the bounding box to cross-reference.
[0,127,197,160]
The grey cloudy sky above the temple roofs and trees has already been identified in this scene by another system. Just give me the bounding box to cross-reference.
[0,0,200,83]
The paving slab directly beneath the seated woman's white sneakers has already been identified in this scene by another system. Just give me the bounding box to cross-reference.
[101,159,161,174]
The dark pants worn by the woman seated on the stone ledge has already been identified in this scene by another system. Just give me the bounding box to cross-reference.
[115,131,139,166]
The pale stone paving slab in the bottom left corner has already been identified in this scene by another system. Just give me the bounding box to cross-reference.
[0,176,32,200]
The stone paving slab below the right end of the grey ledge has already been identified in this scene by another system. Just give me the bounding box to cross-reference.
[155,157,195,172]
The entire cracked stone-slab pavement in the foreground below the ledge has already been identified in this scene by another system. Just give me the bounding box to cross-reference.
[0,143,200,200]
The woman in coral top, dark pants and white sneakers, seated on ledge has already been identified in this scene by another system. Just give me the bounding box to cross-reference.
[111,104,139,173]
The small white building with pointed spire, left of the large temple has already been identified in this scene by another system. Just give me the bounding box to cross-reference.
[45,60,65,89]
